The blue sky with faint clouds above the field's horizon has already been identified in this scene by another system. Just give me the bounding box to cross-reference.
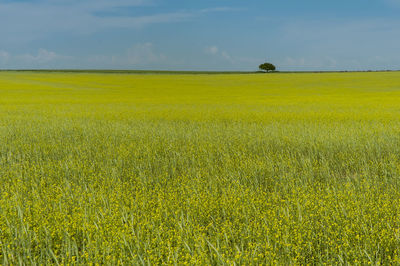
[0,0,400,70]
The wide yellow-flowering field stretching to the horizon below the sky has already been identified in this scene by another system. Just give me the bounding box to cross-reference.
[0,72,400,265]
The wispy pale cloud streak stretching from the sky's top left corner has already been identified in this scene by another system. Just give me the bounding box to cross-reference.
[0,0,193,43]
